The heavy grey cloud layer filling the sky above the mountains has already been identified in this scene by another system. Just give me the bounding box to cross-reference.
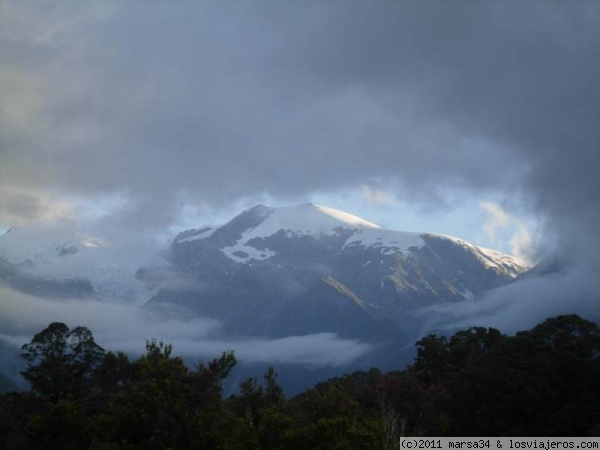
[0,0,600,250]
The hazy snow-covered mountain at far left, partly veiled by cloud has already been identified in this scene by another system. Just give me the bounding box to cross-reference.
[0,226,157,303]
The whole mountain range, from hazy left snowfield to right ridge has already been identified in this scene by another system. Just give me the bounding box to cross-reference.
[0,204,527,390]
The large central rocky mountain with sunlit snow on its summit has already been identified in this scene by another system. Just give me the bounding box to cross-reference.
[148,204,526,341]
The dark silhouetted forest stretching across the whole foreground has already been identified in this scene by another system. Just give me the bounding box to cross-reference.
[0,315,600,450]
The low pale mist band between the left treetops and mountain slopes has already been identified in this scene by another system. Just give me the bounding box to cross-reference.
[0,287,372,371]
